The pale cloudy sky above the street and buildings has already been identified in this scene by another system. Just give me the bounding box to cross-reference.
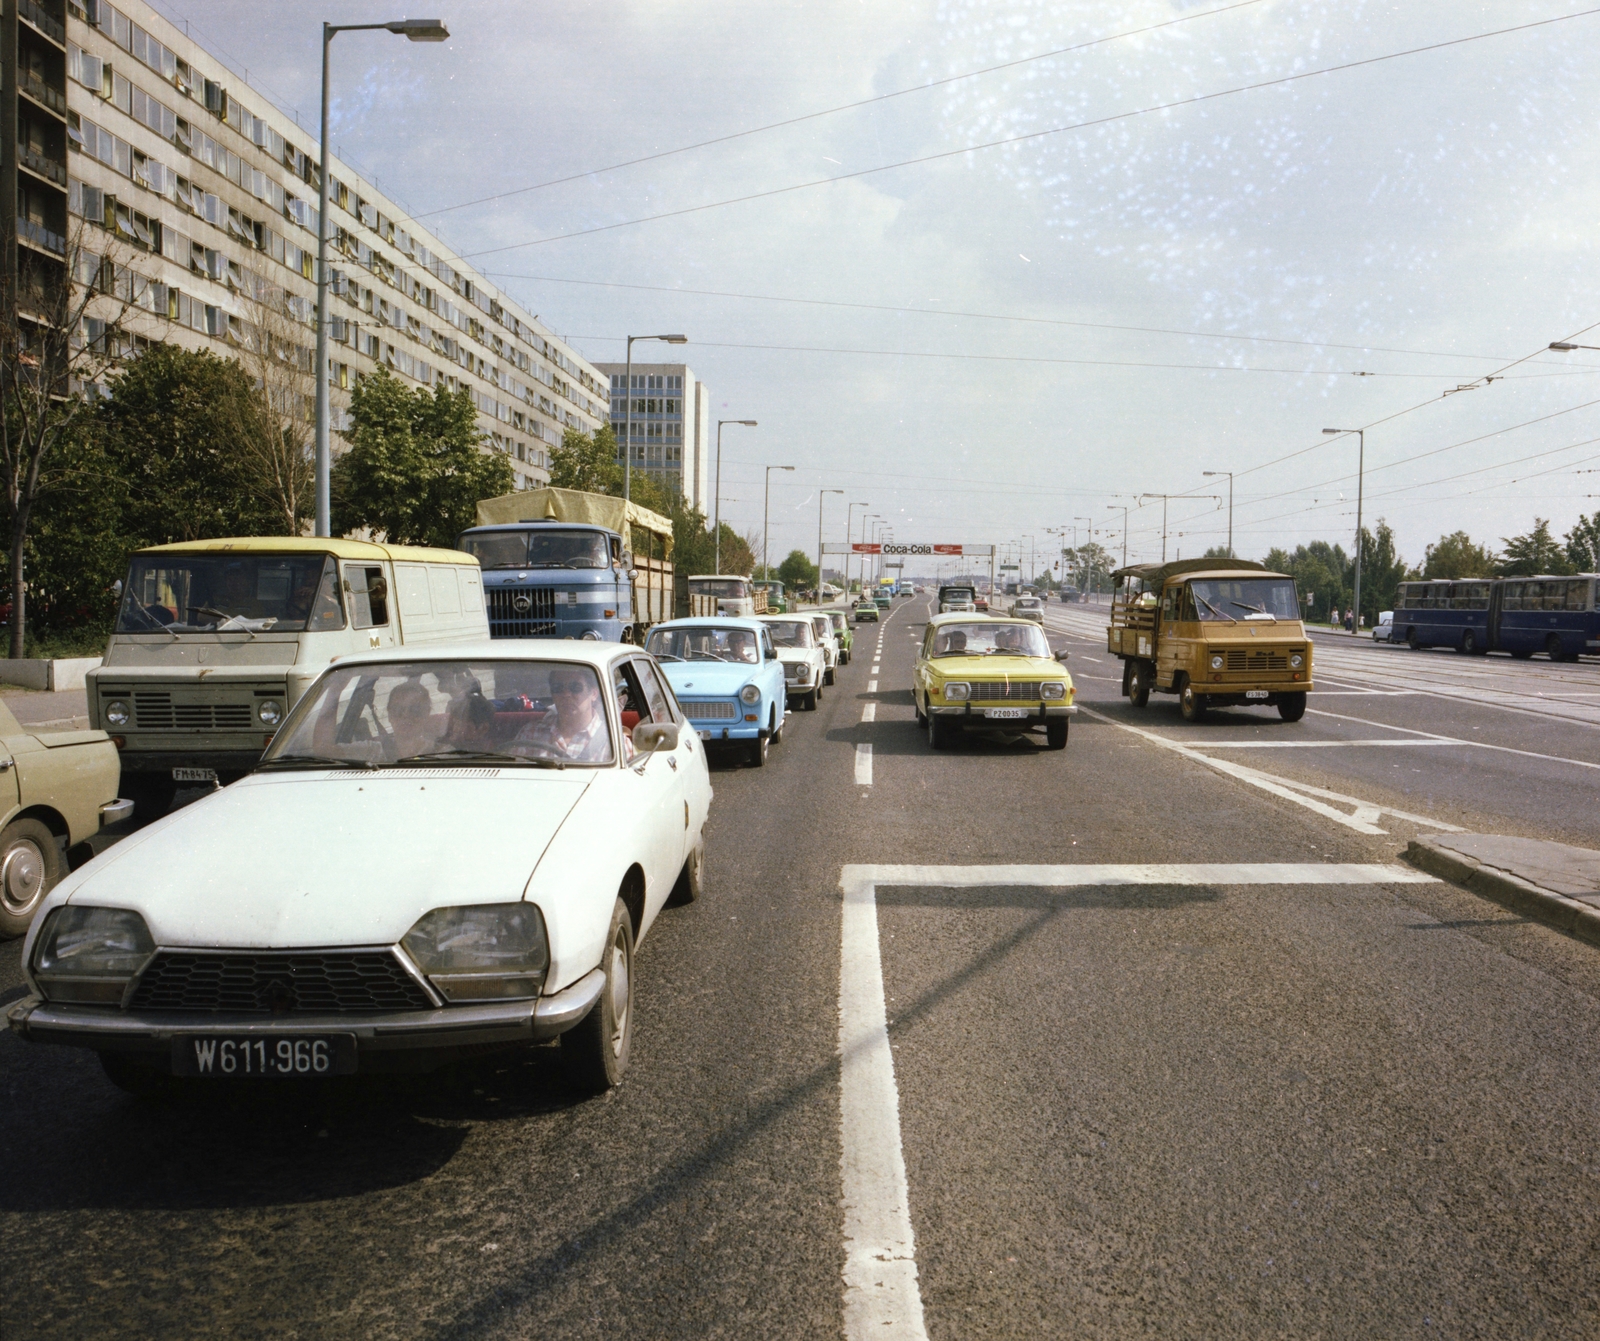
[147,0,1600,566]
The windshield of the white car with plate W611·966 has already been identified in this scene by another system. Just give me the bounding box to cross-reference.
[261,661,613,768]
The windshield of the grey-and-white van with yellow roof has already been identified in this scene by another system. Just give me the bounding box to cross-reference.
[117,554,344,634]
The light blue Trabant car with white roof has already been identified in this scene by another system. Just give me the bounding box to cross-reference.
[645,616,786,768]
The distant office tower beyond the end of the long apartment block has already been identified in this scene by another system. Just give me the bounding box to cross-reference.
[595,363,710,517]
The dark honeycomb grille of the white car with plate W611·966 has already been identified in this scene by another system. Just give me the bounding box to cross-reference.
[131,951,434,1015]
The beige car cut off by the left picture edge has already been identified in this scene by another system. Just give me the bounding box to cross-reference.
[0,703,133,938]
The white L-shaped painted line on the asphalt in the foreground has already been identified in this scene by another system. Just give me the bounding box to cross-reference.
[838,861,1437,1341]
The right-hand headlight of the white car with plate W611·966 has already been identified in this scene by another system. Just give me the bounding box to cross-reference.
[400,903,550,1002]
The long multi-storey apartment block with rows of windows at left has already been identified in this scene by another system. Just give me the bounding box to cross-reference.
[0,0,610,488]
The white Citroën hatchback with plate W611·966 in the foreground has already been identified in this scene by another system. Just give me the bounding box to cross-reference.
[8,640,712,1093]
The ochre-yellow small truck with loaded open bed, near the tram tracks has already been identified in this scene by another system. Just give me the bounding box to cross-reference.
[1106,558,1312,722]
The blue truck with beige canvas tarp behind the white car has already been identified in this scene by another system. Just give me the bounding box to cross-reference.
[459,488,674,643]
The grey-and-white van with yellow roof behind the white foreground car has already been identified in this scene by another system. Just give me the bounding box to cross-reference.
[88,536,490,818]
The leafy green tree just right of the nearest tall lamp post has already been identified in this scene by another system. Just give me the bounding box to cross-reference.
[333,368,515,549]
